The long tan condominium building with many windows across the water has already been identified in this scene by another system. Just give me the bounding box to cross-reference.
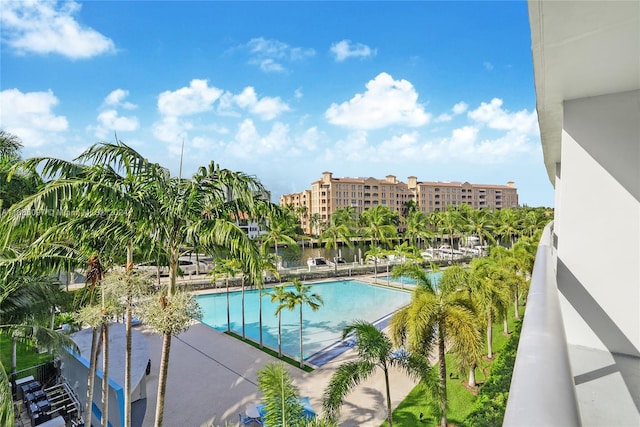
[280,172,518,233]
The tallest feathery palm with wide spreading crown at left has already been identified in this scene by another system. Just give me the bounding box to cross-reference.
[3,141,264,425]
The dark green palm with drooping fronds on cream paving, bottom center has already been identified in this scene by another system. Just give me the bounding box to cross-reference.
[322,320,429,427]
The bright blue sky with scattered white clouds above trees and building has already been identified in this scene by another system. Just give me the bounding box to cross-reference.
[0,0,553,206]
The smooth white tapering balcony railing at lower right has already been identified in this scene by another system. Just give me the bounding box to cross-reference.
[503,223,581,427]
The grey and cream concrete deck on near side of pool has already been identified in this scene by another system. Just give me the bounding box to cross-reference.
[137,277,415,427]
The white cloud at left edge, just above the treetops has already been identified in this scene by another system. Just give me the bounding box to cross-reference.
[0,89,69,147]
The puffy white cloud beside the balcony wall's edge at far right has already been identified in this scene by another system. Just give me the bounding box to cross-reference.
[468,98,538,135]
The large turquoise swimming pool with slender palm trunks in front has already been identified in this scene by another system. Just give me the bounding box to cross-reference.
[196,280,411,360]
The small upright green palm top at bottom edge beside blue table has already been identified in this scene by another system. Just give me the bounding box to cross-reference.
[258,363,304,427]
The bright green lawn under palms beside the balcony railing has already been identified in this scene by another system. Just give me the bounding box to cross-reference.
[382,308,522,427]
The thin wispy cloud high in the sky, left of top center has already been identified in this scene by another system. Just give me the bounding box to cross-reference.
[245,37,316,73]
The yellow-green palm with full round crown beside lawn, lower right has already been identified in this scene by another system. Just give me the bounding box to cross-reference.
[389,264,482,427]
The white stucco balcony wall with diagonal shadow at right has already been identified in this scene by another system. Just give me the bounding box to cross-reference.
[555,91,640,355]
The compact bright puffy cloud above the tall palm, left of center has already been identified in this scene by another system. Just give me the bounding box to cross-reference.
[158,79,223,117]
